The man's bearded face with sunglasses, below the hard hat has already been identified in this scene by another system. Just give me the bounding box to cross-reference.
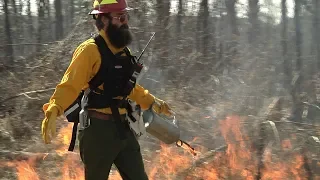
[106,12,132,48]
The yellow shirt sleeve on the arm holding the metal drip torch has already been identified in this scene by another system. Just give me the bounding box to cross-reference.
[128,84,155,110]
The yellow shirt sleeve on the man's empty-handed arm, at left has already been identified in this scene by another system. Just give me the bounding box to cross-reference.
[48,42,101,115]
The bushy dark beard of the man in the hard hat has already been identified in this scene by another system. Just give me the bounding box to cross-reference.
[106,21,132,48]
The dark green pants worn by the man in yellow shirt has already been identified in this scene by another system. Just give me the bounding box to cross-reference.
[79,115,148,180]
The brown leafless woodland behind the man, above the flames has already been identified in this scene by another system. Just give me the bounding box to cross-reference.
[0,0,320,179]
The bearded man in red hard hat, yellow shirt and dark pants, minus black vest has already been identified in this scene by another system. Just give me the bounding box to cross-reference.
[42,0,172,180]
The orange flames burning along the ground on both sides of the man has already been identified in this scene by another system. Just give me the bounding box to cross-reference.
[0,116,320,180]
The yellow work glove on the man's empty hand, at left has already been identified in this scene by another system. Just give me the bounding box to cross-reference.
[41,104,58,144]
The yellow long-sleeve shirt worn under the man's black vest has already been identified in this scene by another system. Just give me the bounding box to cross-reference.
[48,31,155,115]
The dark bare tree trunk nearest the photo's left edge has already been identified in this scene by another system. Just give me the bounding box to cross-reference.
[3,0,13,65]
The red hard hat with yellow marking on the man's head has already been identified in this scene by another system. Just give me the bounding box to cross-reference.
[89,0,131,15]
